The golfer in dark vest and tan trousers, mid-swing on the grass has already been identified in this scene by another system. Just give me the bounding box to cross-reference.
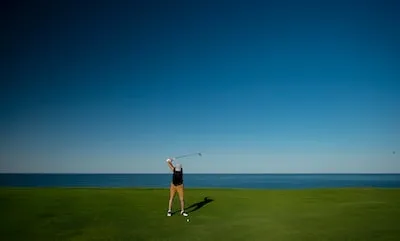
[166,158,188,217]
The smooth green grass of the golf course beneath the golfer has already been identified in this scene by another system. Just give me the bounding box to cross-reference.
[0,188,400,241]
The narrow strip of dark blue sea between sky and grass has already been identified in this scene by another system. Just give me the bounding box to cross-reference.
[0,174,400,189]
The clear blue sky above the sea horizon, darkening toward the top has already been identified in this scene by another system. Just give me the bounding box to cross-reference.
[0,0,400,173]
